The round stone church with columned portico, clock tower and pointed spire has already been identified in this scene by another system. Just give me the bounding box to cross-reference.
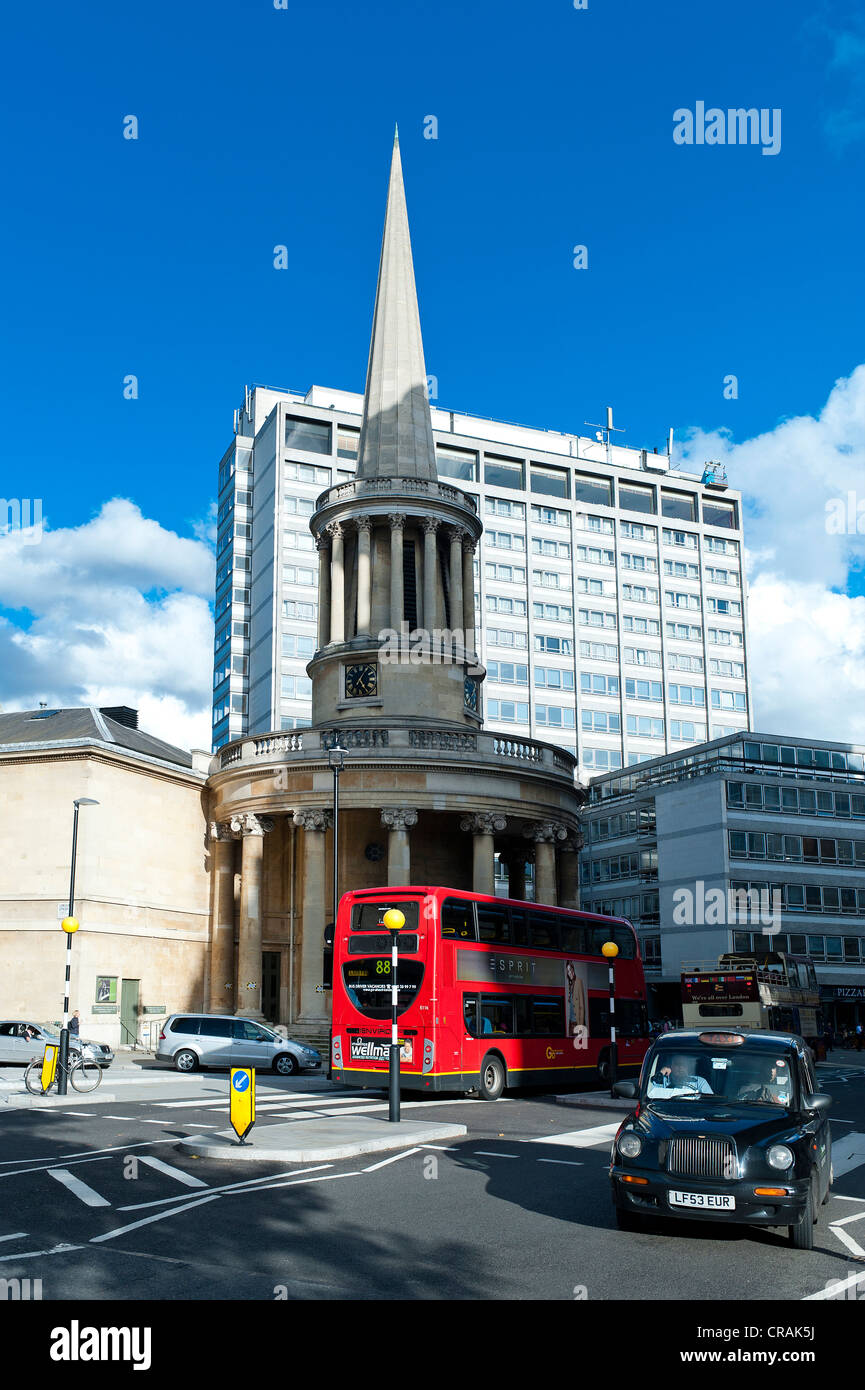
[204,139,584,1040]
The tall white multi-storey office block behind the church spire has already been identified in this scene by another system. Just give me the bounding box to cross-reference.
[213,344,751,777]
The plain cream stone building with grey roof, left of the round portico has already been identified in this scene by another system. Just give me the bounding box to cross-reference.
[0,708,210,1047]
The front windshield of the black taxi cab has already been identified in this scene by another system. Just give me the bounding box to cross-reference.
[642,1044,795,1109]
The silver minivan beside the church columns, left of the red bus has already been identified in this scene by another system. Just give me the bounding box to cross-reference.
[156,1013,321,1076]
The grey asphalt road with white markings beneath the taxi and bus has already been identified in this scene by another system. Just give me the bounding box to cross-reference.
[0,1069,865,1302]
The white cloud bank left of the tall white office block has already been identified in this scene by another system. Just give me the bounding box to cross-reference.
[0,498,214,748]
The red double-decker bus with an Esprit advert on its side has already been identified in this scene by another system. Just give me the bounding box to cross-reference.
[331,887,648,1099]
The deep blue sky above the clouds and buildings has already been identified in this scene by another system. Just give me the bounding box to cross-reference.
[0,0,865,750]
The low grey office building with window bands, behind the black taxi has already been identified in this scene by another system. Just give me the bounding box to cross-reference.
[580,734,865,1026]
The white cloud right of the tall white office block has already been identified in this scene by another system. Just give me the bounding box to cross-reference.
[681,366,865,742]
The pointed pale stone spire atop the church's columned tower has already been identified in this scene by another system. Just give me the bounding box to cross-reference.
[357,128,437,480]
